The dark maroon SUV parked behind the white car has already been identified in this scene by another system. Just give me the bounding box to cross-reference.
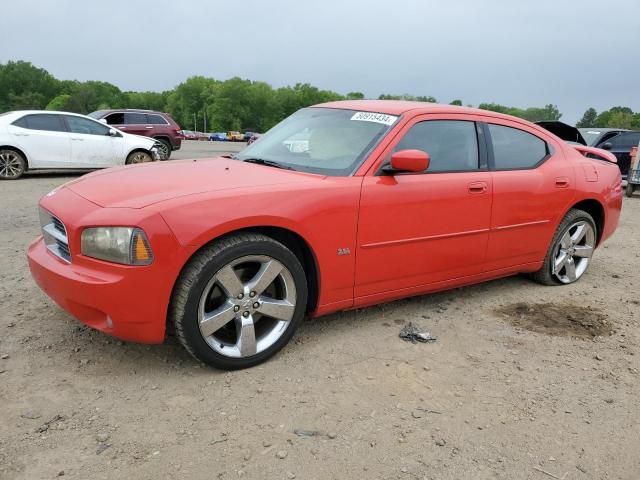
[89,109,182,160]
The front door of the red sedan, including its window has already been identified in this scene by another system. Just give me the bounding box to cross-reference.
[355,116,493,303]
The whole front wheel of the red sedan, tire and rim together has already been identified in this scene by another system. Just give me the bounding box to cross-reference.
[169,233,308,370]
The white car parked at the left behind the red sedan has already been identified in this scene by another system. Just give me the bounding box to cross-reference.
[0,110,159,180]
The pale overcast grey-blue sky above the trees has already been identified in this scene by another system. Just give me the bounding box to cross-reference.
[0,0,640,123]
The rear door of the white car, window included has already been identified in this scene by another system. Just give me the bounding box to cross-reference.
[8,113,71,168]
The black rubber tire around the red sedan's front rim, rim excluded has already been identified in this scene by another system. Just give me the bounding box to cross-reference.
[176,241,307,370]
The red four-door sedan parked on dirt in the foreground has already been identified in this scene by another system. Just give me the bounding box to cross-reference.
[28,101,622,369]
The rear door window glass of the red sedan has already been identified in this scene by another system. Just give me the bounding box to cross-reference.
[489,124,549,170]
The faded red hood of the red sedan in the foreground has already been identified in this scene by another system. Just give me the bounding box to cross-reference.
[66,158,324,208]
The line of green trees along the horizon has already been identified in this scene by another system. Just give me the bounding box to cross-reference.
[0,61,640,132]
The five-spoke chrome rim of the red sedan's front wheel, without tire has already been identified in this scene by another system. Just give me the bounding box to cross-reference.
[198,255,296,358]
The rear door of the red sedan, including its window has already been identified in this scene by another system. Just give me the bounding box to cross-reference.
[484,119,575,271]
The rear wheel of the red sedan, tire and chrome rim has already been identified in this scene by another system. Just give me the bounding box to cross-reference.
[531,209,598,286]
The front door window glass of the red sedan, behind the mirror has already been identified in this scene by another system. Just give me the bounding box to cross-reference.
[394,120,478,172]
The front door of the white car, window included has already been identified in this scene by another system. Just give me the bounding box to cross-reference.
[65,115,124,168]
